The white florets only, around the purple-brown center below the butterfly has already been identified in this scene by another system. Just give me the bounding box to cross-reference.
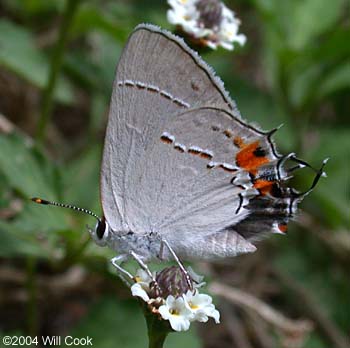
[131,269,220,331]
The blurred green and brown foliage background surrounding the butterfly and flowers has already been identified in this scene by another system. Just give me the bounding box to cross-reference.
[0,0,350,348]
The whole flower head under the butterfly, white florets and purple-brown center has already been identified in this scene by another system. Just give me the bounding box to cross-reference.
[131,266,220,331]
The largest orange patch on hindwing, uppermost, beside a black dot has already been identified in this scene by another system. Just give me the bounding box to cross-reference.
[236,141,269,175]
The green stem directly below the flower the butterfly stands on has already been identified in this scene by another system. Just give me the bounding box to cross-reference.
[141,303,172,348]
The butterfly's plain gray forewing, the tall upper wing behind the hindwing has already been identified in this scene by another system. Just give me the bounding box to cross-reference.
[101,25,242,231]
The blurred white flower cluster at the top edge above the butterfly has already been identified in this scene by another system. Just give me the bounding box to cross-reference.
[167,0,246,50]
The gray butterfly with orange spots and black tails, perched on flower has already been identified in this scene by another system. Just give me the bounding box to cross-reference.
[33,25,326,274]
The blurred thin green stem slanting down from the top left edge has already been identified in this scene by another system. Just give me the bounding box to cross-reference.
[36,0,81,142]
